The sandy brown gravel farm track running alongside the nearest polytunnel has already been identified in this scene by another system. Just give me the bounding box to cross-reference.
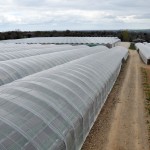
[82,43,150,150]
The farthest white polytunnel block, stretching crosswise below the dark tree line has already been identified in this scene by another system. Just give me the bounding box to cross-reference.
[1,37,120,46]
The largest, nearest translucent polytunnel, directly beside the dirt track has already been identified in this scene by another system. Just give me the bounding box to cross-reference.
[0,48,128,150]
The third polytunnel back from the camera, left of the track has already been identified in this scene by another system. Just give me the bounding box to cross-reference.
[0,45,87,61]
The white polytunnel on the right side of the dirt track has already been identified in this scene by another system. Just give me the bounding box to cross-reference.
[135,43,150,64]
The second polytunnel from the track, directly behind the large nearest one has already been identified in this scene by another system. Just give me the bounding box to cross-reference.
[0,46,109,85]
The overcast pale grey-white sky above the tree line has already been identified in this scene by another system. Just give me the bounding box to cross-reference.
[0,0,150,31]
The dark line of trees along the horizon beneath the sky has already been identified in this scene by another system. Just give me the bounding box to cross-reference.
[0,30,150,42]
